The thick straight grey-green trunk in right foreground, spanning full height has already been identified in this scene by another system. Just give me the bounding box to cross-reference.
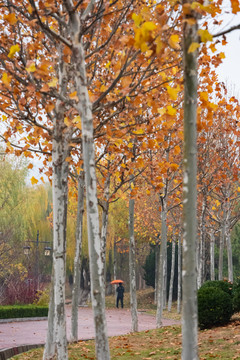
[182,4,198,360]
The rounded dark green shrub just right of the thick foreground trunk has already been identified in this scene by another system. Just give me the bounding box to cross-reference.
[198,286,233,329]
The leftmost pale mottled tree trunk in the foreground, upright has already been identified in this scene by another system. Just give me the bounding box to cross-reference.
[45,45,72,360]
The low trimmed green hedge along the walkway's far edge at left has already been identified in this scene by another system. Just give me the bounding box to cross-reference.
[0,305,48,319]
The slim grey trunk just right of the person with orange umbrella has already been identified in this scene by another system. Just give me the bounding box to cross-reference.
[129,175,138,331]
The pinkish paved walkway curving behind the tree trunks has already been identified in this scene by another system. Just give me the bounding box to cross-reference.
[0,306,179,349]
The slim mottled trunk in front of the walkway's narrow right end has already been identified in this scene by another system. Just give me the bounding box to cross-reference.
[156,196,167,328]
